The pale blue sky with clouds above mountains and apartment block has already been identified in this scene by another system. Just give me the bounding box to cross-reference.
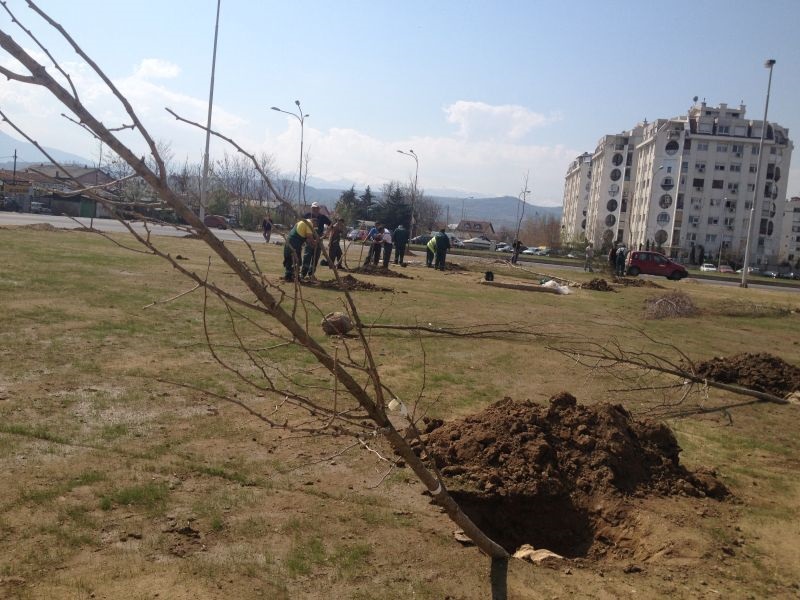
[0,0,800,206]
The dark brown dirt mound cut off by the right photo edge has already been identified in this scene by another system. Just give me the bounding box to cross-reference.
[695,352,800,398]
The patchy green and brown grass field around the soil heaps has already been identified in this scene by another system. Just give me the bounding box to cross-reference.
[0,228,800,600]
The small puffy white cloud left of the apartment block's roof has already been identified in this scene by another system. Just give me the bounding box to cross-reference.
[444,100,560,140]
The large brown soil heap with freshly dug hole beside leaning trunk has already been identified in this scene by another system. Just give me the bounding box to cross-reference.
[423,392,728,558]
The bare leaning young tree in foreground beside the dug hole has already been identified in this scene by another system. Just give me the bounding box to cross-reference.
[0,7,508,598]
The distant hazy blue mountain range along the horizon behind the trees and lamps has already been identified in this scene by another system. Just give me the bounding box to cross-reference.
[0,131,561,229]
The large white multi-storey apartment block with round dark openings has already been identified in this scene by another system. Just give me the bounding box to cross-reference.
[564,102,793,264]
